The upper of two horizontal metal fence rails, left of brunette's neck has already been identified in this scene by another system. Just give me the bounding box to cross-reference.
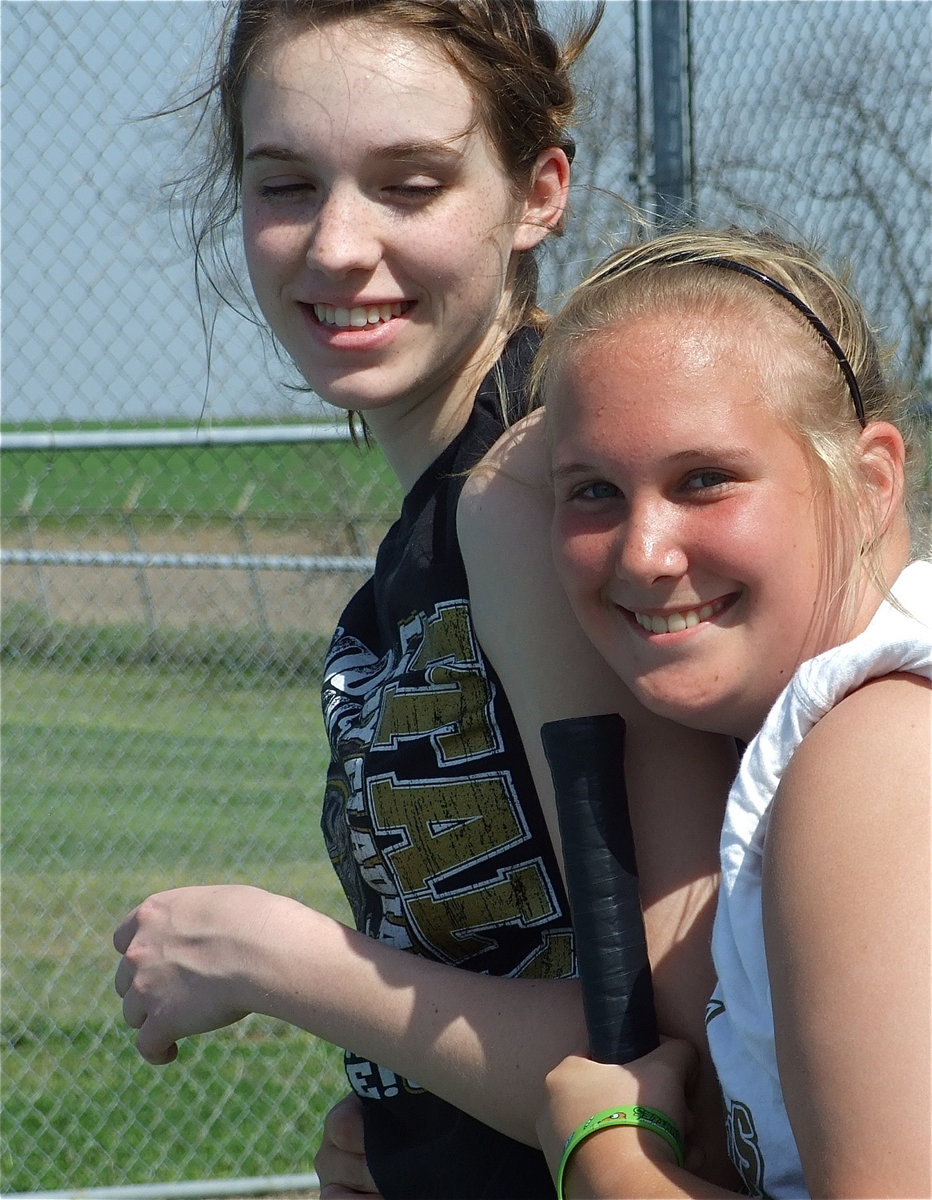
[0,421,351,450]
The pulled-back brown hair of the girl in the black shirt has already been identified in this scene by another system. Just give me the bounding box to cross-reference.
[181,0,605,338]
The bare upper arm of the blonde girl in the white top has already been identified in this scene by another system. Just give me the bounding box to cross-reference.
[764,676,932,1196]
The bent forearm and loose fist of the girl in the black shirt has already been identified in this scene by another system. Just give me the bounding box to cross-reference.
[114,884,584,1145]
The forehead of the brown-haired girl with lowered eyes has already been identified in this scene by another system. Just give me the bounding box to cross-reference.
[242,19,476,152]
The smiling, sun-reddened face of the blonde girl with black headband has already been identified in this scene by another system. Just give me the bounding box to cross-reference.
[547,313,831,739]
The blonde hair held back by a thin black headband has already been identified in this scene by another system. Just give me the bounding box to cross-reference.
[531,229,922,628]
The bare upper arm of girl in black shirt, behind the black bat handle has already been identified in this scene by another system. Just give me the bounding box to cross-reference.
[459,413,736,1181]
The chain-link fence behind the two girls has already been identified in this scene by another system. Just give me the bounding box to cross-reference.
[0,0,932,1195]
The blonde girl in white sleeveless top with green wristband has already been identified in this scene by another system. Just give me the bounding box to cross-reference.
[539,230,932,1198]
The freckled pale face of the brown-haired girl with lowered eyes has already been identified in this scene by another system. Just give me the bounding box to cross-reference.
[242,19,558,427]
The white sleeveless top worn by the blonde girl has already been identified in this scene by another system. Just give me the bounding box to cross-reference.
[705,562,932,1198]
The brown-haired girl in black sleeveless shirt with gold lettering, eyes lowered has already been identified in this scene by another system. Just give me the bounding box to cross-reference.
[115,7,730,1200]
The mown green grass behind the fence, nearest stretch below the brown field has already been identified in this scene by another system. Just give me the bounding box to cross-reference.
[0,660,345,1193]
